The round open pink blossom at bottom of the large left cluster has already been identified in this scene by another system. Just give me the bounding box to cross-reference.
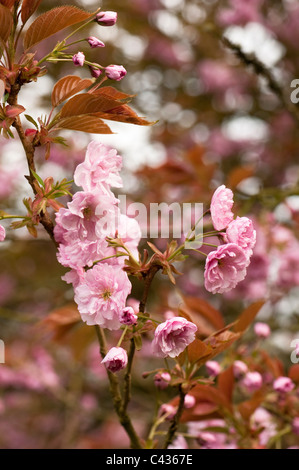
[75,263,132,330]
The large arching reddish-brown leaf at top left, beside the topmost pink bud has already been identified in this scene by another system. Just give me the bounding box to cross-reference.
[24,5,93,49]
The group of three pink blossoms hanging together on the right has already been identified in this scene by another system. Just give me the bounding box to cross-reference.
[204,185,256,294]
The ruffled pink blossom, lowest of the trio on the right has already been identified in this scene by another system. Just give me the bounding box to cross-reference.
[204,243,248,294]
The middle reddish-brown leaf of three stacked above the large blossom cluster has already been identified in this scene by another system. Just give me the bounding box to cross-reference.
[60,93,123,118]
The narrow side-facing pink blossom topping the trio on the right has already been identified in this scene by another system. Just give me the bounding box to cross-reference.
[210,184,234,230]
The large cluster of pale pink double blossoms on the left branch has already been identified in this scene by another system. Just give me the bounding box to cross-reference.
[54,141,141,330]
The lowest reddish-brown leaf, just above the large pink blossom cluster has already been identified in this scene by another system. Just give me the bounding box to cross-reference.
[55,114,113,134]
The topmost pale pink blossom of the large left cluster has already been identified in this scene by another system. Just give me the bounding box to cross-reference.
[74,141,122,193]
